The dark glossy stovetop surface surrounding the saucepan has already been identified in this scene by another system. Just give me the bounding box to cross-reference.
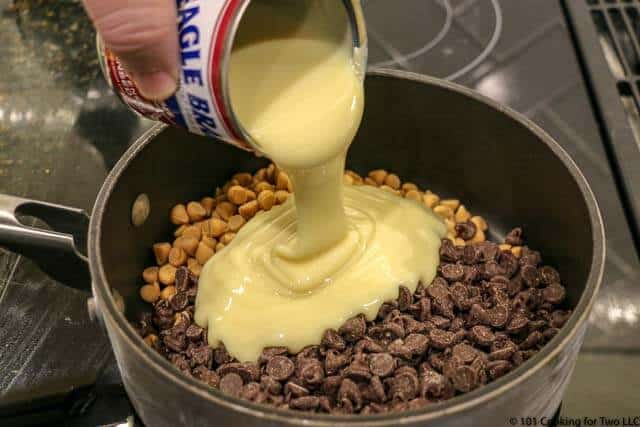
[0,0,640,426]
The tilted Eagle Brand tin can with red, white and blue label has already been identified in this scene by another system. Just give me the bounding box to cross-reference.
[98,0,367,151]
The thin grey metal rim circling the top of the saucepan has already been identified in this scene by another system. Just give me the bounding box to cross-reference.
[88,69,605,426]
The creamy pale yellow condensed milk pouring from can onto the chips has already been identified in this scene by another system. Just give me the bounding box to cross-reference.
[195,0,446,361]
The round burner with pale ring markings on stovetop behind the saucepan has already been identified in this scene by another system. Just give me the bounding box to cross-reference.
[364,0,502,80]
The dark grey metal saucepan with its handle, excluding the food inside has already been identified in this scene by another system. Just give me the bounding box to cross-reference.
[0,70,605,427]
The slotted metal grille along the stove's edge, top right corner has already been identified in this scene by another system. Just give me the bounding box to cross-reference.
[561,0,640,249]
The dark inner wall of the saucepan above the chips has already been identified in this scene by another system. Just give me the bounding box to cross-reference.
[99,75,594,404]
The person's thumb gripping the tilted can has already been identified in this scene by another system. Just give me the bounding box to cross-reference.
[84,0,179,101]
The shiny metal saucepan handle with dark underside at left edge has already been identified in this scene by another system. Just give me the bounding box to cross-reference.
[0,194,91,290]
